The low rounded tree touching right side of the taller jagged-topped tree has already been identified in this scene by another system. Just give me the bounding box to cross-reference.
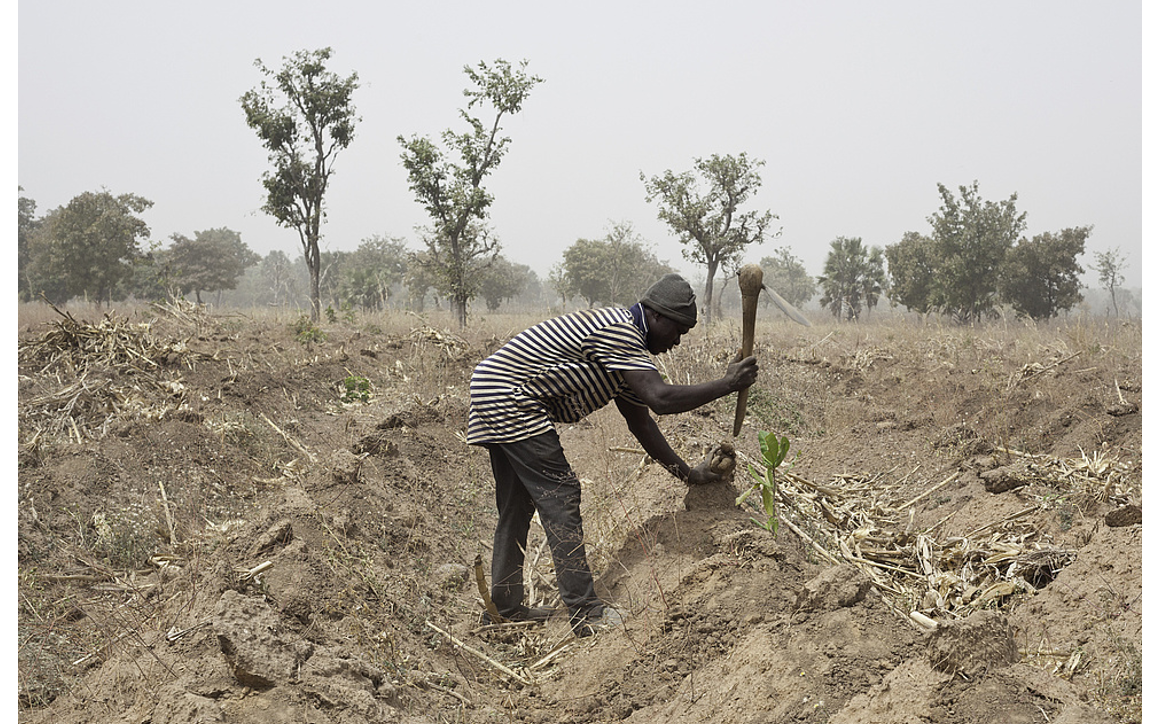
[1001,226,1091,319]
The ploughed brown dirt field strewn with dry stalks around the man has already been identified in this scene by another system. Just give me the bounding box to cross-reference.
[17,305,1142,724]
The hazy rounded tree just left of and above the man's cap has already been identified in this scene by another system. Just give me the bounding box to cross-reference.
[562,222,674,307]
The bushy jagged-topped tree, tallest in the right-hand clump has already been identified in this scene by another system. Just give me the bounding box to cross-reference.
[929,182,1026,322]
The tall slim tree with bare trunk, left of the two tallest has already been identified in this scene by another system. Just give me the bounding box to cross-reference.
[239,47,359,322]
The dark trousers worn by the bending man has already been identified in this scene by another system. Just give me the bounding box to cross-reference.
[486,431,601,621]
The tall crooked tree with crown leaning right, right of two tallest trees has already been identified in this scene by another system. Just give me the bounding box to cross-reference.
[398,59,543,328]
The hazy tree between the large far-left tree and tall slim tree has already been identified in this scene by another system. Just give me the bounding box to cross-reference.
[166,228,260,303]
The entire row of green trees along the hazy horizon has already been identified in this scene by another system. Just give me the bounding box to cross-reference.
[18,48,1125,326]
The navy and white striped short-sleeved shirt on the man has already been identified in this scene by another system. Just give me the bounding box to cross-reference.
[467,305,658,445]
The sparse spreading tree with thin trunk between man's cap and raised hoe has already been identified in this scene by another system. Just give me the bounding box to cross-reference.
[639,153,774,323]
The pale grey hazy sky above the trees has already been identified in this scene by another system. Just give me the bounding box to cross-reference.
[18,0,1142,286]
